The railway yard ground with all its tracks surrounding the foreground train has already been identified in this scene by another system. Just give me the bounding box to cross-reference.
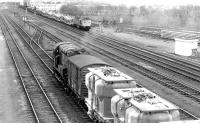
[0,5,200,123]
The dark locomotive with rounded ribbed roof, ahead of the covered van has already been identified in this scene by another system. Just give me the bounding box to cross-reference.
[53,42,86,82]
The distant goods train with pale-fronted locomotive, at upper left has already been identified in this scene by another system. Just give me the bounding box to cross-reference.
[20,6,92,31]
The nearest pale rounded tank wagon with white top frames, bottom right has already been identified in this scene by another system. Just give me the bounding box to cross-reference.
[111,88,180,123]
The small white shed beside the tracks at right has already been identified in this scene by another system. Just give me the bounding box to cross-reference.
[175,38,198,56]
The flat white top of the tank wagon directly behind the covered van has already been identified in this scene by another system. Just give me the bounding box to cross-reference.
[88,67,134,82]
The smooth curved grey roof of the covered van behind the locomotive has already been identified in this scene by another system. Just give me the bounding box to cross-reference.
[69,54,110,68]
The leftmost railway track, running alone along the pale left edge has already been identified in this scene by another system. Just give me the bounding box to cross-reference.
[1,15,62,123]
